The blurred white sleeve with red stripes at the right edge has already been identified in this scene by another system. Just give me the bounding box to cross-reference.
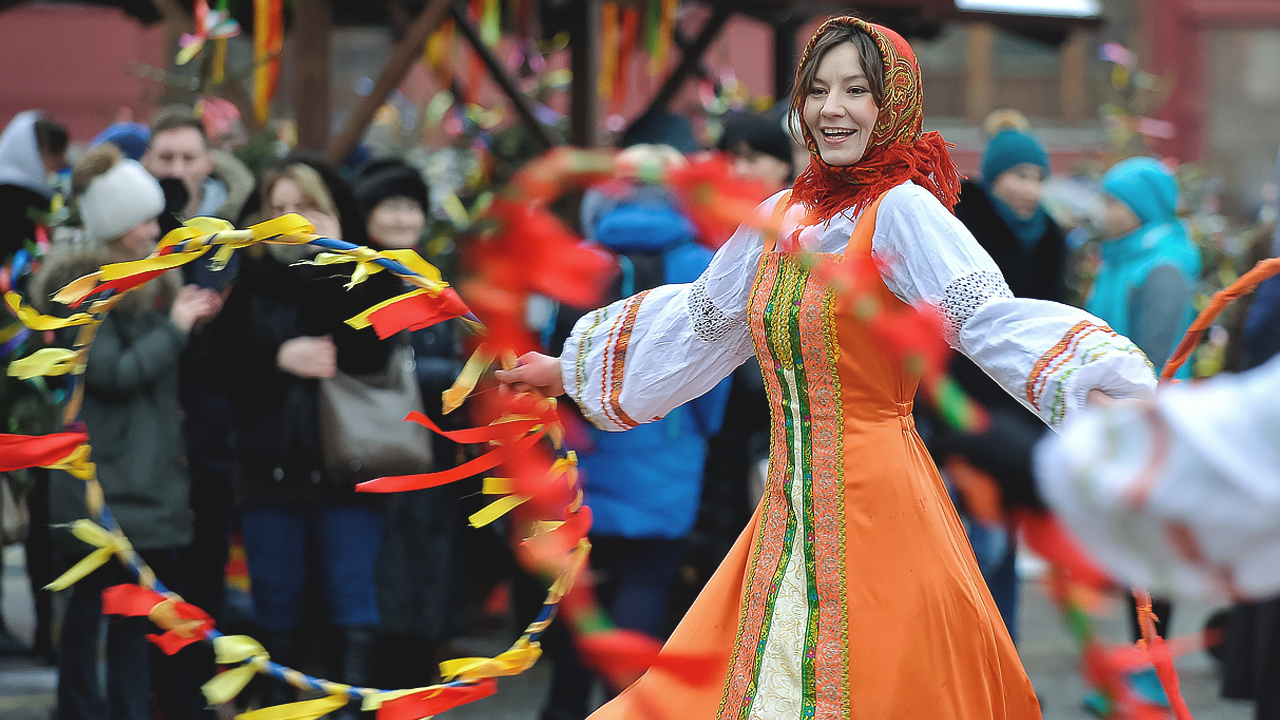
[1036,357,1280,598]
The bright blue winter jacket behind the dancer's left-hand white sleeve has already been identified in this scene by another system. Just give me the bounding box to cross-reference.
[557,188,730,538]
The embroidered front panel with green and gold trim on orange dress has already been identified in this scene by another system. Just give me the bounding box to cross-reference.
[718,254,849,720]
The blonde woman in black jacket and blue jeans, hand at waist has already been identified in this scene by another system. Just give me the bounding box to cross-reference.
[211,159,398,712]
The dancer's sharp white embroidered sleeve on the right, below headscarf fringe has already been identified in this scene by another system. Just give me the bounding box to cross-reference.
[872,183,1156,428]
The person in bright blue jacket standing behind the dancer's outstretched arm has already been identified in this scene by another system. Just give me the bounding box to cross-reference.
[543,145,730,720]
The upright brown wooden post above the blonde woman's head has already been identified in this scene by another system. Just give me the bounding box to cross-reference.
[293,0,333,150]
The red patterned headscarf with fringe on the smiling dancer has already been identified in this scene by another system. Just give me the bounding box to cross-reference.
[791,17,960,222]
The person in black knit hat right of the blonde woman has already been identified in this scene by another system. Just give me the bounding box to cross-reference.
[355,160,463,688]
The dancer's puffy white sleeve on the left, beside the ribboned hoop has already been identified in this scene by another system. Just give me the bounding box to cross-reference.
[561,193,781,430]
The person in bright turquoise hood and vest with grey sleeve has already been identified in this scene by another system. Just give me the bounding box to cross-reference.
[1084,158,1201,378]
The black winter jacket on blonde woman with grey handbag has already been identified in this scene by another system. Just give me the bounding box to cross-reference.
[210,252,399,505]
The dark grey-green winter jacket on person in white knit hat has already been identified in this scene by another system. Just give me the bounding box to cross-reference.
[49,245,192,550]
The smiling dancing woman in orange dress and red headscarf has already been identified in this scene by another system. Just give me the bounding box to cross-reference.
[499,17,1155,720]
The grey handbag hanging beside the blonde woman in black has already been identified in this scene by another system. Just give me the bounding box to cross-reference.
[319,345,431,483]
